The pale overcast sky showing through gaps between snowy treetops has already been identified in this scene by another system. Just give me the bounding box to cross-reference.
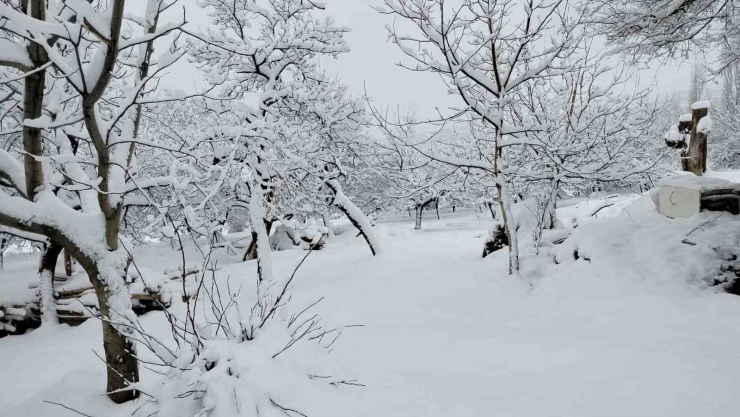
[153,0,691,115]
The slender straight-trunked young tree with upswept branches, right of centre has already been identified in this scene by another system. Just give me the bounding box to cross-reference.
[378,0,578,274]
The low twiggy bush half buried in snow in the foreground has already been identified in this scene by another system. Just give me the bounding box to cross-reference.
[135,252,361,417]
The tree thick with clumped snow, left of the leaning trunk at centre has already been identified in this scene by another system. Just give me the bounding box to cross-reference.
[182,0,348,270]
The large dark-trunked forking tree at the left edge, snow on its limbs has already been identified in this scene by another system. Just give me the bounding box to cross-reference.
[0,0,184,402]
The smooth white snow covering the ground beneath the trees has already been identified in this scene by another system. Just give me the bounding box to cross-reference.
[0,195,740,417]
